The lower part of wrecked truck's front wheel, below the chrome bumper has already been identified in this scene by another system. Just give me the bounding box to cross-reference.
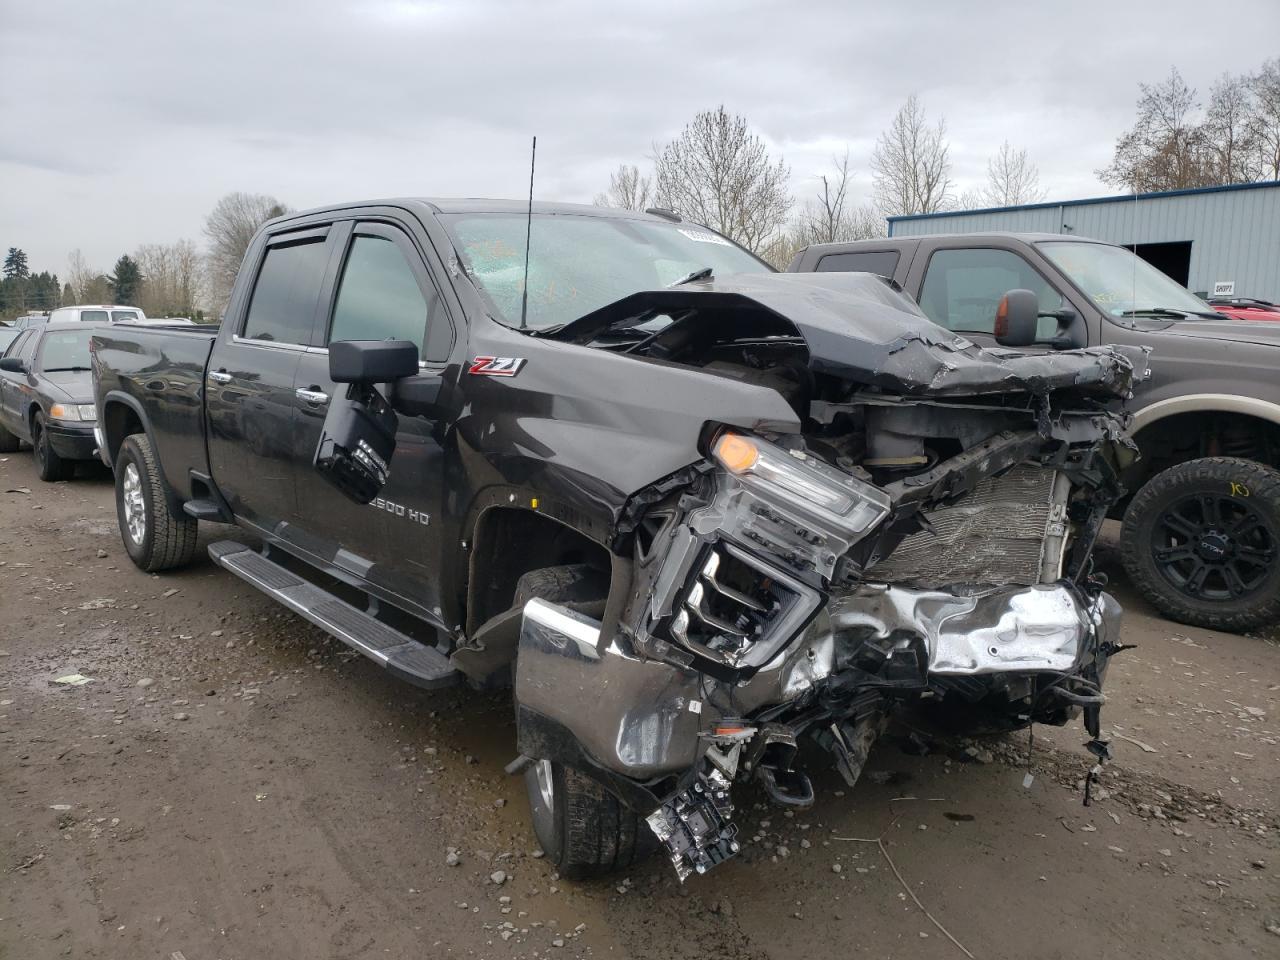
[525,760,655,879]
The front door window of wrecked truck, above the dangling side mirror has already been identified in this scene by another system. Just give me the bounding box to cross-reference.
[329,233,451,360]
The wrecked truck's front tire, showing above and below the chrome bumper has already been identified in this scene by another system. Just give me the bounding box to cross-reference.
[516,563,657,879]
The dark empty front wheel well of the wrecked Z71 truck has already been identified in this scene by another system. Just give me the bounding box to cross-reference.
[467,507,613,635]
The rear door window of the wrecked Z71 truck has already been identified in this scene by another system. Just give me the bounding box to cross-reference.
[243,237,328,344]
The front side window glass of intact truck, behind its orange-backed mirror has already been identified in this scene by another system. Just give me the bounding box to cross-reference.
[920,250,1062,335]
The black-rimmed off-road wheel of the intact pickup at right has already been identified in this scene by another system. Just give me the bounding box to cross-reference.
[1120,457,1280,632]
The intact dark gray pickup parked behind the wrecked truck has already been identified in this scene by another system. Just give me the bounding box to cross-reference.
[790,233,1280,631]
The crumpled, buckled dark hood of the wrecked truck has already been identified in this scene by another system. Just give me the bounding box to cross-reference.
[553,273,1146,397]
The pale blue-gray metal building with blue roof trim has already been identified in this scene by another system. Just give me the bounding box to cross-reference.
[888,180,1280,303]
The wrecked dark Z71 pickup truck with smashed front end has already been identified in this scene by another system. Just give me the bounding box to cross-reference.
[93,200,1146,878]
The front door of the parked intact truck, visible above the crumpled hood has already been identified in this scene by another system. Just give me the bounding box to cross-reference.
[908,239,1074,349]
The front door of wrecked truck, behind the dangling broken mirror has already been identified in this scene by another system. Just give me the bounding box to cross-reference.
[293,221,453,620]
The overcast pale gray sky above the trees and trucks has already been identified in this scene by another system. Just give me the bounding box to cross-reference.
[0,0,1280,274]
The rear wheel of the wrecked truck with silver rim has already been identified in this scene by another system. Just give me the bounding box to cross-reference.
[115,434,200,573]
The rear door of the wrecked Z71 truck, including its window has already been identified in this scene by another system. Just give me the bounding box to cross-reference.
[205,225,333,536]
